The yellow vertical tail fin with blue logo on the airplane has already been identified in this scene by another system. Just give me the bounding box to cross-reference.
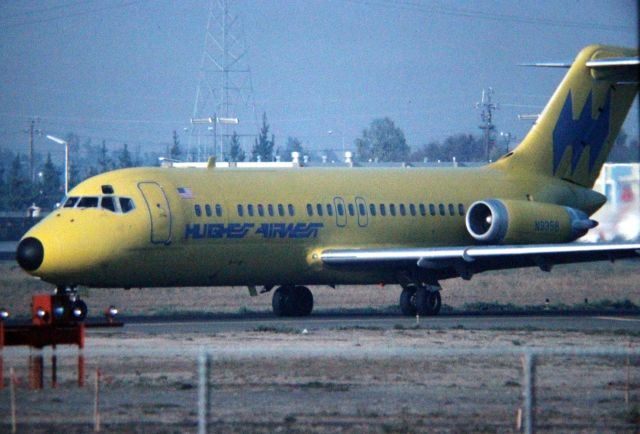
[494,45,638,188]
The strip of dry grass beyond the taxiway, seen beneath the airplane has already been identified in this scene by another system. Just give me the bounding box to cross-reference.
[0,261,640,316]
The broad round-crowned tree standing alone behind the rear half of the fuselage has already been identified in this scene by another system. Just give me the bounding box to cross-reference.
[356,118,410,161]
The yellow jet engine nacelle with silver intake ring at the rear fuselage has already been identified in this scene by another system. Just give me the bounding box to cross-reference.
[466,199,598,244]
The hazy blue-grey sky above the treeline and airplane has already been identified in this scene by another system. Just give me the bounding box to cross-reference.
[0,0,638,159]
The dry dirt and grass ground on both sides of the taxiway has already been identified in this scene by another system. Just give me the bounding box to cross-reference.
[0,261,640,433]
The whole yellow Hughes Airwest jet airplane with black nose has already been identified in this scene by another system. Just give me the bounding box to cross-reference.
[16,45,640,319]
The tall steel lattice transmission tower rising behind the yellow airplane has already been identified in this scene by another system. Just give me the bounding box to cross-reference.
[187,0,258,161]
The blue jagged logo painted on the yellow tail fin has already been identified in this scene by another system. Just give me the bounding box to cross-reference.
[553,90,611,174]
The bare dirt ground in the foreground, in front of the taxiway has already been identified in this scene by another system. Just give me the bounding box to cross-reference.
[0,328,640,433]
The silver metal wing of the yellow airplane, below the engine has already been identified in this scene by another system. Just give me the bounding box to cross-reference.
[320,243,640,279]
